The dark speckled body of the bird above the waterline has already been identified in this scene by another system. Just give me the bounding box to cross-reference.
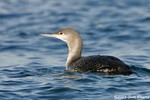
[68,55,132,74]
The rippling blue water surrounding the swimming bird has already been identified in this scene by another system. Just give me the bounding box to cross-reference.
[0,0,150,100]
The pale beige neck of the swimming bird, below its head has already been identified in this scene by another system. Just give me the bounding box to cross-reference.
[66,37,82,69]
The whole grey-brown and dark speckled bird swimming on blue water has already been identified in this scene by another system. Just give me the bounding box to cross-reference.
[41,28,132,75]
